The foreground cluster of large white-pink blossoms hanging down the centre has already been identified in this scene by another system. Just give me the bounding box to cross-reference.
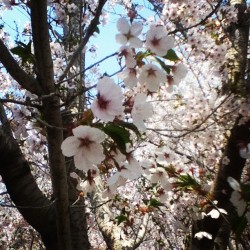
[60,18,187,199]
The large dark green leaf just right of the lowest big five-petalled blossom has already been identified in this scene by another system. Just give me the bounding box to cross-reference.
[101,123,131,154]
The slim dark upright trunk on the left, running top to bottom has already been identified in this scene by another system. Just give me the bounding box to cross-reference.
[30,0,71,250]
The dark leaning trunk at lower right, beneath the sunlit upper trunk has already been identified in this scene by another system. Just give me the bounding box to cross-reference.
[190,118,250,250]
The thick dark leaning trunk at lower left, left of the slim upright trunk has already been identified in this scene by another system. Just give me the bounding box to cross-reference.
[0,104,58,250]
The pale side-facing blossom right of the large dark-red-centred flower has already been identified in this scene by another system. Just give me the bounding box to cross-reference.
[131,93,153,131]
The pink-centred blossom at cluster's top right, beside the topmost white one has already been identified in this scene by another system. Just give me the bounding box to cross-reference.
[145,25,174,56]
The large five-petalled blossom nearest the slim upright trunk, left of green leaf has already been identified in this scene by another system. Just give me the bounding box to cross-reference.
[61,125,105,171]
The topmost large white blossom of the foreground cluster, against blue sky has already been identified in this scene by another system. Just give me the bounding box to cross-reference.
[116,17,143,48]
